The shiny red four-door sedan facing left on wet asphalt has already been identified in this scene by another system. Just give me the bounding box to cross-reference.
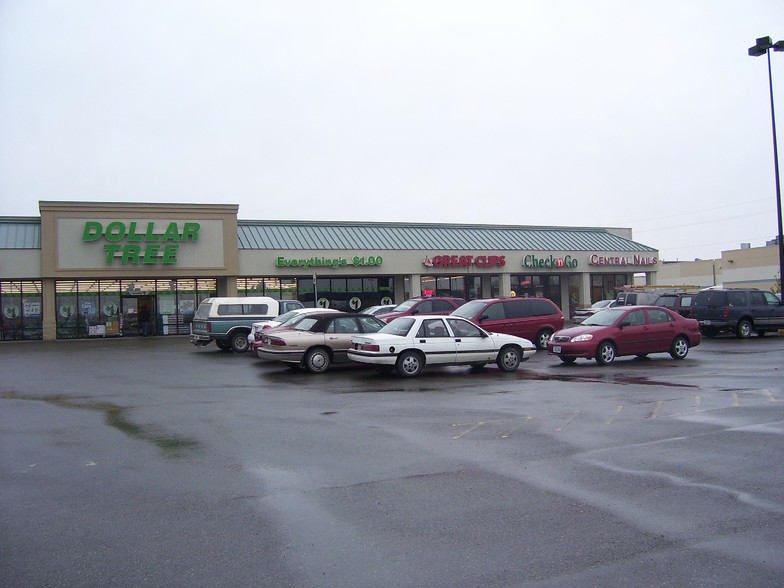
[547,306,701,365]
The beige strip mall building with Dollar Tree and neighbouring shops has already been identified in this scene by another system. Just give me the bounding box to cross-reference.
[0,202,659,340]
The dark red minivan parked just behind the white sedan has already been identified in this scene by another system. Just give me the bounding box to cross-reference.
[451,297,564,349]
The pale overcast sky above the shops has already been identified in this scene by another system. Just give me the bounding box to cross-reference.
[0,0,784,260]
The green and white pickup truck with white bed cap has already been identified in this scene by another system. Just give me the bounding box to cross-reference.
[191,296,305,352]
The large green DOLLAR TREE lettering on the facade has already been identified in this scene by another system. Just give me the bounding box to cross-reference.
[82,221,201,265]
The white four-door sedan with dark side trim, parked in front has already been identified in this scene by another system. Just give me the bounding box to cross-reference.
[348,315,536,376]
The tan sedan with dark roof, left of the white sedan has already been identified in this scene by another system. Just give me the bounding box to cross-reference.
[256,311,386,373]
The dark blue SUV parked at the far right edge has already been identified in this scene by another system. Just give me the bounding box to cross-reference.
[691,288,784,339]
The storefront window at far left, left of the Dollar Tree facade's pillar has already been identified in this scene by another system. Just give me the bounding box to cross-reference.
[0,280,43,340]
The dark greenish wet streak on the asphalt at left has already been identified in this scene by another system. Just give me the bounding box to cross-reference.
[0,392,199,458]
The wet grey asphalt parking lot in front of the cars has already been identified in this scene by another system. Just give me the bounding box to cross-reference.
[0,336,784,587]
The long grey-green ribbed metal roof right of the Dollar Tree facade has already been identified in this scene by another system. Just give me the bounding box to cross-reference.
[237,221,656,252]
